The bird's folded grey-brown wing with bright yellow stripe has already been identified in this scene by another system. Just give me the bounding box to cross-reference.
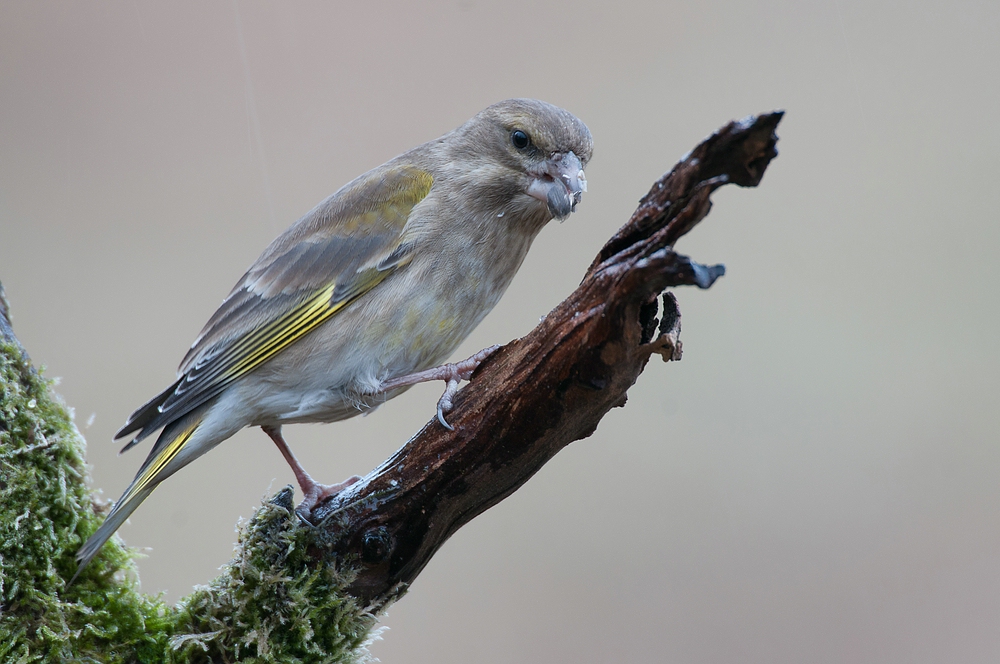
[115,165,433,451]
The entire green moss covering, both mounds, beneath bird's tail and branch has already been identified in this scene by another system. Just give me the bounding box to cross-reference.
[0,344,376,663]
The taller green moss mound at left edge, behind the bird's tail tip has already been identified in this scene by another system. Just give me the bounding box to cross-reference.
[0,344,169,662]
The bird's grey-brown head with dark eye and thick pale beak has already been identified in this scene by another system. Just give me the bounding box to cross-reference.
[450,99,594,219]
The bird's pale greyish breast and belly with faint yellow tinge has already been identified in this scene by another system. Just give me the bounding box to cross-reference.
[247,208,534,422]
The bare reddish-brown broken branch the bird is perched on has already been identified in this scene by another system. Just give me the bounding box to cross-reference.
[312,112,782,605]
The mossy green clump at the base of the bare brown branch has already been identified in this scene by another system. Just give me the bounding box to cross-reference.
[173,487,375,663]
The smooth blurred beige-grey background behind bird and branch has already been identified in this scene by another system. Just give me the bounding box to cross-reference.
[0,0,1000,663]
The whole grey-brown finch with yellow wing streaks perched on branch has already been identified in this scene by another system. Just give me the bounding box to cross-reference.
[74,99,593,578]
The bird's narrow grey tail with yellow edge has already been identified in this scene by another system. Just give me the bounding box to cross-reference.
[70,412,204,583]
